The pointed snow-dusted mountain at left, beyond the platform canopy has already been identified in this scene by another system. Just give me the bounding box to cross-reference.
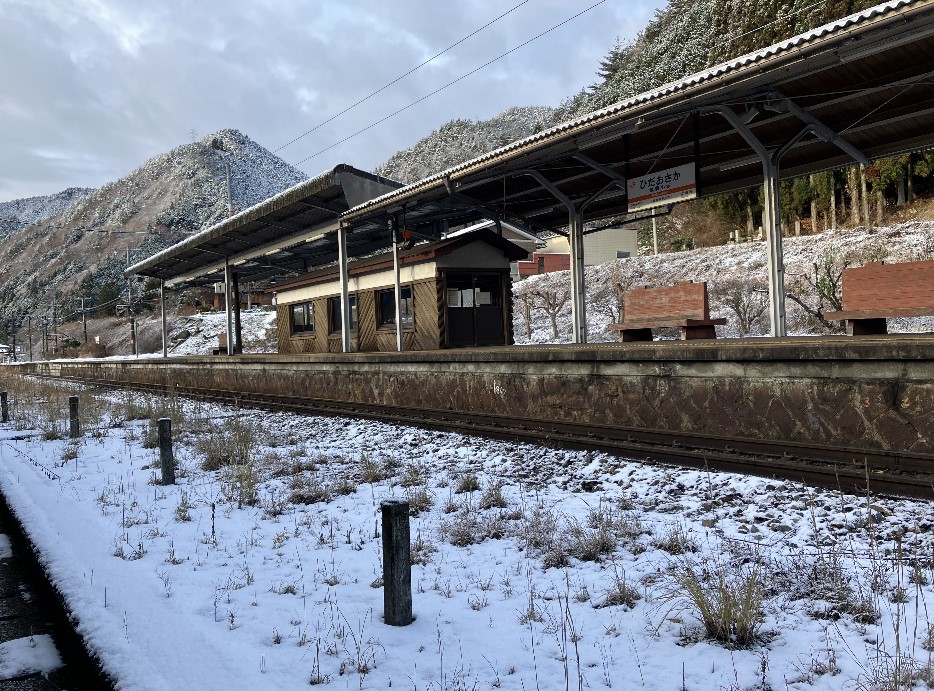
[0,129,307,336]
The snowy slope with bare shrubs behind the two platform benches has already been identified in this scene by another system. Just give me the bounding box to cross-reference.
[513,221,934,344]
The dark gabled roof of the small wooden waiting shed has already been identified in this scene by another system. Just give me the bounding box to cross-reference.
[276,228,529,291]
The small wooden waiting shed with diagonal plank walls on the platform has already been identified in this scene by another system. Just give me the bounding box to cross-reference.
[276,229,528,353]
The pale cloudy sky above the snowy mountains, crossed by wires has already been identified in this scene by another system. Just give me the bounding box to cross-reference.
[0,0,666,201]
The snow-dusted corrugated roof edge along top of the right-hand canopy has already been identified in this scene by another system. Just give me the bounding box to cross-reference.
[342,0,931,217]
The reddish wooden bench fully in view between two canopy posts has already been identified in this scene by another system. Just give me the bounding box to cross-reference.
[609,281,726,342]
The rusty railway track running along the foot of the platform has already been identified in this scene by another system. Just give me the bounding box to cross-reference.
[51,377,934,499]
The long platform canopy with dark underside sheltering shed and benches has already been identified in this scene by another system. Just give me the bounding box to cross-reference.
[128,0,934,342]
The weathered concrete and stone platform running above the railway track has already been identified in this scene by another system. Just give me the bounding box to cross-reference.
[7,335,934,454]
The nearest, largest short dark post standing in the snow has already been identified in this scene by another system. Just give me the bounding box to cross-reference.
[379,499,412,626]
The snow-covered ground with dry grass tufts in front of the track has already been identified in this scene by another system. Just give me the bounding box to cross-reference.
[0,380,934,691]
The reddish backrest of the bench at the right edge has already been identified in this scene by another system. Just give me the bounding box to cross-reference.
[843,261,934,310]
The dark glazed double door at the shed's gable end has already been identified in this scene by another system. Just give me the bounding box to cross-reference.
[446,273,506,348]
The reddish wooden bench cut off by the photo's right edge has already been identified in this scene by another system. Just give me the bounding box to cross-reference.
[824,261,934,336]
